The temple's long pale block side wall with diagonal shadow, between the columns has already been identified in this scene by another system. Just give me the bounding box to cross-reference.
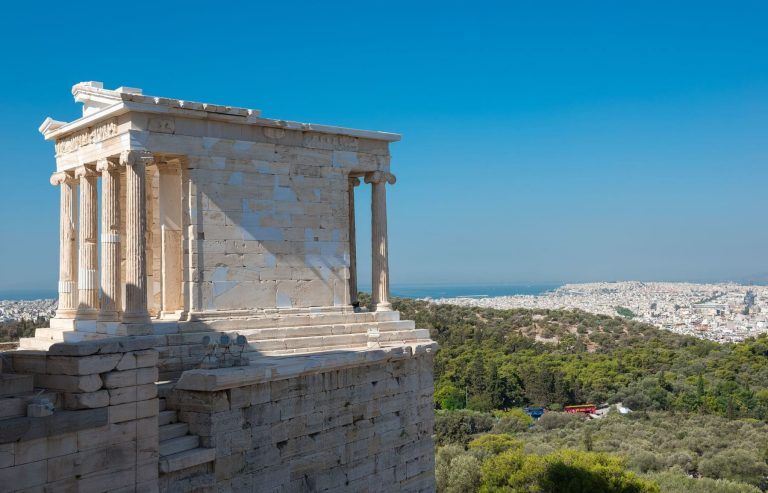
[148,123,389,313]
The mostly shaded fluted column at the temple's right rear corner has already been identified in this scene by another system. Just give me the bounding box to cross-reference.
[365,171,395,311]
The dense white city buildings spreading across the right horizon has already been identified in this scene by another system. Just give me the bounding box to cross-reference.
[434,281,768,342]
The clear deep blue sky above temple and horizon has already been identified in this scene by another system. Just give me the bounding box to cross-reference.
[0,0,768,290]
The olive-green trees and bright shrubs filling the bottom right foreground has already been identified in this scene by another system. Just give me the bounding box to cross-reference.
[437,411,768,493]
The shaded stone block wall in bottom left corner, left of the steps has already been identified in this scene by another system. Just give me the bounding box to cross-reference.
[0,338,159,492]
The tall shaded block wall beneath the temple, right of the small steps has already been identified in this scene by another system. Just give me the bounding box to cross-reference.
[160,346,434,492]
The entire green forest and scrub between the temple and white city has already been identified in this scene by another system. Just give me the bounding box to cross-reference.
[395,299,768,493]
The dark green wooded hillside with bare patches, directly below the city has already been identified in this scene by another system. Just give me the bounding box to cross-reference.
[395,299,768,420]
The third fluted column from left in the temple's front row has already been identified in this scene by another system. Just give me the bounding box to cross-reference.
[96,159,120,322]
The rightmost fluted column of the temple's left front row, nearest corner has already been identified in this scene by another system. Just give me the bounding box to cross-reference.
[120,151,152,323]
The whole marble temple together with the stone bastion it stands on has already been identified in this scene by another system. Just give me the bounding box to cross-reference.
[0,82,437,492]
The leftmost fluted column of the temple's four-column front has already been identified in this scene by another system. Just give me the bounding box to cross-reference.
[51,172,77,319]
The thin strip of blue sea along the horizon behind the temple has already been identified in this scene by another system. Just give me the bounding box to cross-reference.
[0,284,560,300]
